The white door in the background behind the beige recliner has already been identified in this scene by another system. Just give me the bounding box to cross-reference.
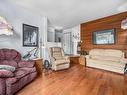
[63,32,71,54]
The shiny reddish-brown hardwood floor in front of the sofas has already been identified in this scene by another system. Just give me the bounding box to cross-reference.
[16,64,127,95]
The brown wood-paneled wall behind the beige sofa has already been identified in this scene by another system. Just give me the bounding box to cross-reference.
[81,12,127,57]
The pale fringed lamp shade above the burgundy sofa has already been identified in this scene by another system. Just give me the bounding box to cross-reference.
[0,16,13,35]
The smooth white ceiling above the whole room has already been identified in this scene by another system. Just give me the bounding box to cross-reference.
[8,0,127,29]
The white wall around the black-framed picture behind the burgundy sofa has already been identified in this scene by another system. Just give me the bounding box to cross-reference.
[0,0,47,57]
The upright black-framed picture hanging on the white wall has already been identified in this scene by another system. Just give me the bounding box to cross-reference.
[23,24,39,47]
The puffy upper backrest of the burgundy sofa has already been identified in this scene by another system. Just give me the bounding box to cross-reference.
[0,49,21,61]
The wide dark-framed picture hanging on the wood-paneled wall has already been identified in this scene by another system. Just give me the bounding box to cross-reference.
[93,29,115,45]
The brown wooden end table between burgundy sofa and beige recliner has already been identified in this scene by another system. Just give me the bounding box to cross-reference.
[33,58,43,75]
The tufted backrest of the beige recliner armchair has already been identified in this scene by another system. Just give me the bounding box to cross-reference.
[49,47,64,59]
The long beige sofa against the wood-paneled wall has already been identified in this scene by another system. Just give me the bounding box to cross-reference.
[86,49,127,74]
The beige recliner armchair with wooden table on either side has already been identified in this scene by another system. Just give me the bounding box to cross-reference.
[49,47,70,71]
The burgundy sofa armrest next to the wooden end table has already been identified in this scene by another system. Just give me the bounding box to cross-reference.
[18,60,35,68]
